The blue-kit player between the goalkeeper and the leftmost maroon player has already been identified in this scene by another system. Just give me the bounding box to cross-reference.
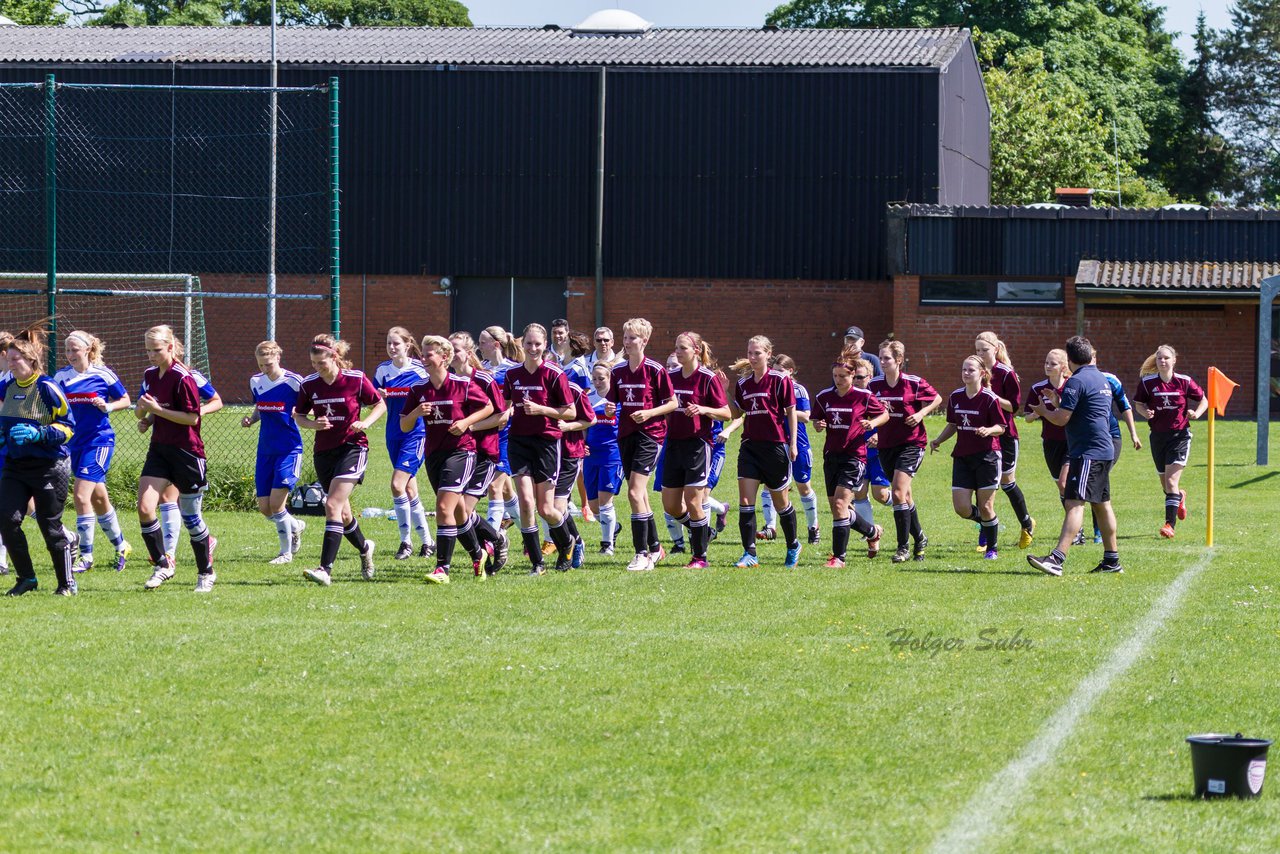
[54,330,133,572]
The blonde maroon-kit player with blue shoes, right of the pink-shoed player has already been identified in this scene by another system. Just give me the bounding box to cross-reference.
[724,335,800,568]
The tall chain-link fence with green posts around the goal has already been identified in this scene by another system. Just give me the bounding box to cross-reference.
[0,76,339,507]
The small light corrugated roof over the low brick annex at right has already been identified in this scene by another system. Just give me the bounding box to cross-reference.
[1075,261,1280,293]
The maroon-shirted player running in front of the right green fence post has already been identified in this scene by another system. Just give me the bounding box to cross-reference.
[293,335,387,586]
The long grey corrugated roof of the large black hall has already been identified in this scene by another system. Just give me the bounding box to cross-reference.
[0,27,969,69]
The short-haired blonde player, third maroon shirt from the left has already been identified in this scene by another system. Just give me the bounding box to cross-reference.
[399,335,493,584]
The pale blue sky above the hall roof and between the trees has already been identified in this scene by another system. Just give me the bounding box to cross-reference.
[462,0,1230,55]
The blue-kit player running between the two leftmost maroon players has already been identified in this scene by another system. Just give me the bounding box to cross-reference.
[241,341,307,566]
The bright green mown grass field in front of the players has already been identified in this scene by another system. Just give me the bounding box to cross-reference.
[0,419,1280,851]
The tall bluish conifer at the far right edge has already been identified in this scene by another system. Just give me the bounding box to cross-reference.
[1213,0,1280,204]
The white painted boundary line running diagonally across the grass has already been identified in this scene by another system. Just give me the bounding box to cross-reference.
[932,549,1213,854]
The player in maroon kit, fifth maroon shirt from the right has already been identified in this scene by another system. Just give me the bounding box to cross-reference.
[868,341,942,563]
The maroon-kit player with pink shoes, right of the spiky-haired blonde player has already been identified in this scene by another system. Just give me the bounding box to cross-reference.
[662,332,731,570]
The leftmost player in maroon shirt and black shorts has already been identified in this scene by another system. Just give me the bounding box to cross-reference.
[134,326,218,593]
